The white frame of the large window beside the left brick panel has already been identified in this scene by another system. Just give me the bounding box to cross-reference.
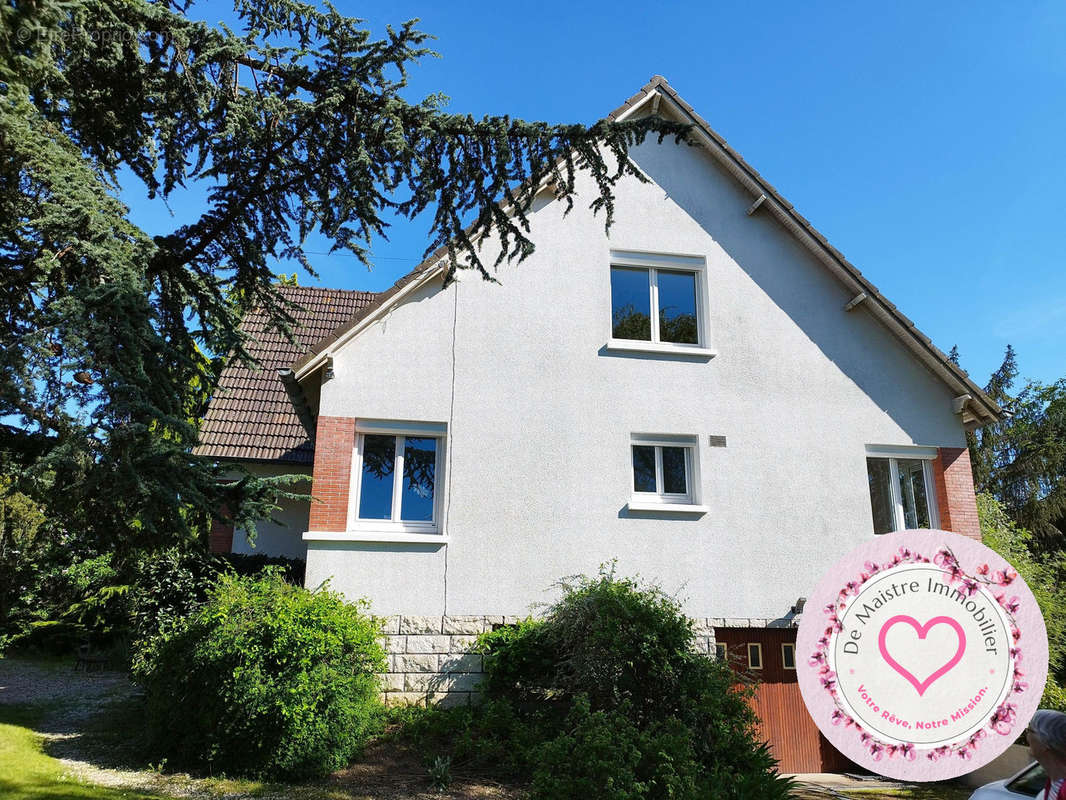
[348,420,446,538]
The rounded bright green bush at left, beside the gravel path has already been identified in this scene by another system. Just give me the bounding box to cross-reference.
[135,567,385,779]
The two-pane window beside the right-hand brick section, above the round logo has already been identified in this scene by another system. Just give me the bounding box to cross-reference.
[867,447,937,533]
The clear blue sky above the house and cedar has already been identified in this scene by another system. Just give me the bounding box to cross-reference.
[126,0,1066,384]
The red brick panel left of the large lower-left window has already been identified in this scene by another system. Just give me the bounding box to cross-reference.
[308,416,355,531]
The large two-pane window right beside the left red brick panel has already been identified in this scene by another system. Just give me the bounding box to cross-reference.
[349,421,443,533]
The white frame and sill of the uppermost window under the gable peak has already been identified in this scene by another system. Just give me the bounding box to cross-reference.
[605,250,714,358]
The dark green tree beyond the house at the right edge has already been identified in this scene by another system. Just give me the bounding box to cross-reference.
[969,346,1066,550]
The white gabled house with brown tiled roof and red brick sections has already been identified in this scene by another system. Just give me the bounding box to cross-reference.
[200,77,1001,771]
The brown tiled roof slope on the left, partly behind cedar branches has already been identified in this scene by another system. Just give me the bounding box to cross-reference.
[194,286,375,464]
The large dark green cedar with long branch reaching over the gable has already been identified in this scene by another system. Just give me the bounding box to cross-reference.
[0,0,687,549]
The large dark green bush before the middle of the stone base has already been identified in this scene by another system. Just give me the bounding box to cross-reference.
[398,571,791,800]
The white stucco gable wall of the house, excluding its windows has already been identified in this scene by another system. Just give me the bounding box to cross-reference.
[308,134,965,619]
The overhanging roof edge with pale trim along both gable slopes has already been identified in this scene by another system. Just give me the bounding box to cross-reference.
[292,75,1004,428]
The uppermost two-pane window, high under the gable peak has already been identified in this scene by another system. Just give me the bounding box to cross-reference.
[609,252,710,354]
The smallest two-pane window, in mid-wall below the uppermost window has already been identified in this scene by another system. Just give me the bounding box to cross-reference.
[629,434,706,511]
